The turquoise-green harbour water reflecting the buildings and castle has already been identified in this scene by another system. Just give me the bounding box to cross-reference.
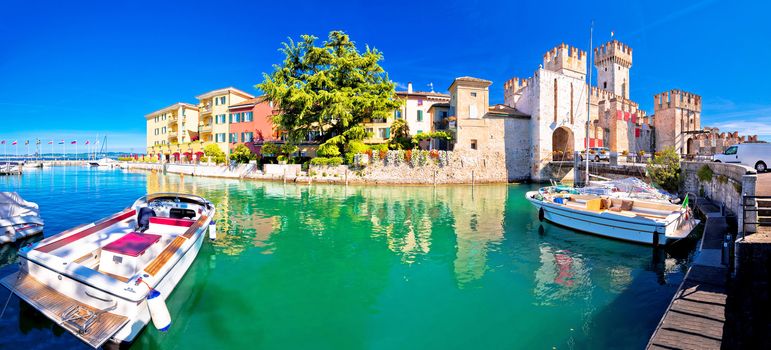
[0,168,688,349]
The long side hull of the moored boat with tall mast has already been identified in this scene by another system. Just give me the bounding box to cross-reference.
[527,194,667,245]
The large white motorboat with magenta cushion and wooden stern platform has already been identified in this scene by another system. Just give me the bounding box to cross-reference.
[0,193,215,348]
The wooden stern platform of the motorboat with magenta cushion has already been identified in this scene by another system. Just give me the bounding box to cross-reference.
[0,272,128,348]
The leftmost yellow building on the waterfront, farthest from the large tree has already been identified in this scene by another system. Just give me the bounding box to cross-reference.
[145,102,198,154]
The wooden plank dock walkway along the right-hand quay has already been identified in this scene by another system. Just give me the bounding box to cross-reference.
[647,199,728,350]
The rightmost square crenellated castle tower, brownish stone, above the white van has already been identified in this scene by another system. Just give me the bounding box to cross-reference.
[653,89,701,154]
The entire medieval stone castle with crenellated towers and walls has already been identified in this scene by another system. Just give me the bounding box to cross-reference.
[440,40,757,181]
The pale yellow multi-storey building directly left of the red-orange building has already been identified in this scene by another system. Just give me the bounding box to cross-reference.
[195,87,254,155]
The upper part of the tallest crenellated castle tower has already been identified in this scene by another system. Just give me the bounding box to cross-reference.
[594,40,632,99]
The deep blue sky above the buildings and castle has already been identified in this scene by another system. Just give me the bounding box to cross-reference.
[0,0,771,152]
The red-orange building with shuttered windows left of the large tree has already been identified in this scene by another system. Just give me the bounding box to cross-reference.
[228,96,279,153]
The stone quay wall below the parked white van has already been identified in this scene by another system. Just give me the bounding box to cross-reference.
[680,162,757,232]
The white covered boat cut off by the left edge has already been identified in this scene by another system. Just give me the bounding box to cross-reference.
[0,192,43,243]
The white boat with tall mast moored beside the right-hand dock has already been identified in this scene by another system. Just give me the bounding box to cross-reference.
[525,187,699,245]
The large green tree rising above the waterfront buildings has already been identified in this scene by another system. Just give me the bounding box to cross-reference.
[256,31,401,143]
